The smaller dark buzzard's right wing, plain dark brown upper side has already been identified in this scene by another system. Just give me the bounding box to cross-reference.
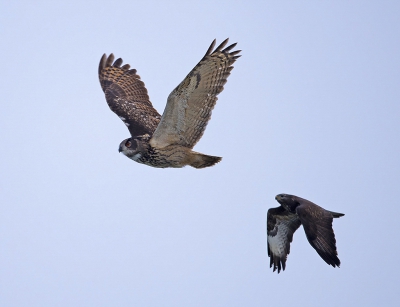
[296,199,341,267]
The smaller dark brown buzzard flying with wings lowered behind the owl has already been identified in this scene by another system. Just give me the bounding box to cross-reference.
[267,194,344,273]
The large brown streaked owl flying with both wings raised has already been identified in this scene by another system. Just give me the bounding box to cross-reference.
[99,39,240,168]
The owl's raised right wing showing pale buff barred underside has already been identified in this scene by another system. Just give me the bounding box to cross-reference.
[150,39,240,148]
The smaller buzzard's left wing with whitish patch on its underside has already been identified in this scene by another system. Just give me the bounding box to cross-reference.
[267,207,301,273]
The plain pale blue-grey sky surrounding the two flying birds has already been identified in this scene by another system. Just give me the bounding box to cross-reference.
[0,0,400,307]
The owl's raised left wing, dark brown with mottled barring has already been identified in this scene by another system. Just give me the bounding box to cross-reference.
[99,53,161,136]
